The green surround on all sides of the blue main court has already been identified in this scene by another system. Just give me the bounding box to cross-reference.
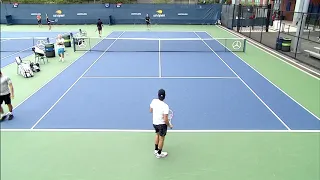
[1,25,320,180]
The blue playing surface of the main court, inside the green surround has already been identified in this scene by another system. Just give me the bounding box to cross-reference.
[1,31,320,130]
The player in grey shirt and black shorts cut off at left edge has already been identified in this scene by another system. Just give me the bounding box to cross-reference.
[0,71,14,121]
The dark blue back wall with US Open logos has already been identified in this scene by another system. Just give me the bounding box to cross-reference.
[1,4,222,24]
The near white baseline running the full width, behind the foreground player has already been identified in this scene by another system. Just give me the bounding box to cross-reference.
[1,129,320,133]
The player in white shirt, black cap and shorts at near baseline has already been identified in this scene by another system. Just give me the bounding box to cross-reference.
[150,89,172,158]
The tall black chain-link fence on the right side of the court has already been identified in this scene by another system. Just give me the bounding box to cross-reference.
[221,5,320,69]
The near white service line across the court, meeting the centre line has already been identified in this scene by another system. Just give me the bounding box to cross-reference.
[81,76,238,79]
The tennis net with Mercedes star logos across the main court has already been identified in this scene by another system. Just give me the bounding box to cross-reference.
[73,37,246,52]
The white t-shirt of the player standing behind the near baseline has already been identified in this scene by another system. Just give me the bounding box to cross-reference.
[150,99,169,125]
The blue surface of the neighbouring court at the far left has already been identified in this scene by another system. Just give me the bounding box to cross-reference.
[0,31,70,68]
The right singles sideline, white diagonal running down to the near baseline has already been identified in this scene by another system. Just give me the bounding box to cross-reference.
[195,33,291,130]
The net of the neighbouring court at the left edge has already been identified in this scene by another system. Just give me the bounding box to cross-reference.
[1,37,48,52]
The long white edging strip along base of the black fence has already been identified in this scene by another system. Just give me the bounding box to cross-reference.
[218,26,320,80]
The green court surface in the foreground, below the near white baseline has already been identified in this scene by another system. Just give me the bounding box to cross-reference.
[1,132,320,180]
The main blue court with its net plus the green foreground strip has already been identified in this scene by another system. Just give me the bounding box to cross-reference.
[1,26,320,180]
